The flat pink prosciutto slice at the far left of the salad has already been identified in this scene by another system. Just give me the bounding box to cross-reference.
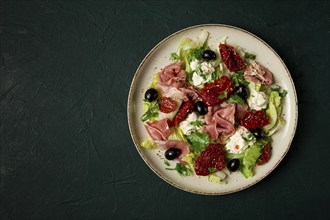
[144,118,171,141]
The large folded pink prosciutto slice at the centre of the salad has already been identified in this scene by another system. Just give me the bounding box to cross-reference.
[203,102,236,143]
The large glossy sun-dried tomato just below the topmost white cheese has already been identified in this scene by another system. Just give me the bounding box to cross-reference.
[200,75,234,106]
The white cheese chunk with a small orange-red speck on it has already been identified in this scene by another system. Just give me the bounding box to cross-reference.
[225,126,256,154]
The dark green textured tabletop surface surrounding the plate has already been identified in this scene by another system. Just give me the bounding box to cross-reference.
[0,0,330,219]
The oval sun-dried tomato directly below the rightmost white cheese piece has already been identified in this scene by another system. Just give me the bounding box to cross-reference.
[241,110,270,129]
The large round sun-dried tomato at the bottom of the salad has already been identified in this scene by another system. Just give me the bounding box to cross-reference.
[195,144,226,176]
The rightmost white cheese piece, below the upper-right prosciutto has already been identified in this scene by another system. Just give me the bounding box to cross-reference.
[247,83,268,110]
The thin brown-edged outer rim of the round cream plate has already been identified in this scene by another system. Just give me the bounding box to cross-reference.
[127,23,298,196]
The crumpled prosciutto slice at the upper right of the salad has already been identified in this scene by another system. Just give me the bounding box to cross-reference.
[244,61,273,85]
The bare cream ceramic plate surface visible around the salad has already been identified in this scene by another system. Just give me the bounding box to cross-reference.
[127,24,298,195]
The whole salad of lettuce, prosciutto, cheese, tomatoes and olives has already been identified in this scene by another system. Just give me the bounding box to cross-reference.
[140,31,286,183]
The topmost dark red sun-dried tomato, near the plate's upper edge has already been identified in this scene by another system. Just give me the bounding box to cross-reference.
[219,44,246,72]
